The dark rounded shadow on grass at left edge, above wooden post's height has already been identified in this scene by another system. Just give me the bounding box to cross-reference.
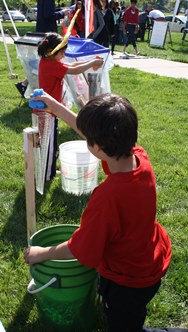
[1,99,31,133]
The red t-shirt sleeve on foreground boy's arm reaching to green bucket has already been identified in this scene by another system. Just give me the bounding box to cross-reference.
[68,191,117,268]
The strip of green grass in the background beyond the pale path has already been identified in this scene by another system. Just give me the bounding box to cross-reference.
[3,22,188,63]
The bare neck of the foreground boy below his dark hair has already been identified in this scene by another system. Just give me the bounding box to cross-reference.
[107,155,138,174]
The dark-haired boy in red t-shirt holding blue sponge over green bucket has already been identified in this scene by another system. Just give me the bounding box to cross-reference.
[24,94,172,332]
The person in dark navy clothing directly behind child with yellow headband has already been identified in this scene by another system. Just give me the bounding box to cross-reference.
[36,0,68,32]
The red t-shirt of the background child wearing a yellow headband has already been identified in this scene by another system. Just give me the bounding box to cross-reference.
[38,58,68,103]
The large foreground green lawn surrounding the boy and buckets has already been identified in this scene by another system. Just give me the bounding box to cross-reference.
[0,43,188,332]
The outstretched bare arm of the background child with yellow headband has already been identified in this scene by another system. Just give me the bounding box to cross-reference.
[66,58,104,75]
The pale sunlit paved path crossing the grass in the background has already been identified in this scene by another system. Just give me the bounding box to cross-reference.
[0,35,188,79]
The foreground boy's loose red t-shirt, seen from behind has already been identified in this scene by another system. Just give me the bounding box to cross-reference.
[68,147,172,288]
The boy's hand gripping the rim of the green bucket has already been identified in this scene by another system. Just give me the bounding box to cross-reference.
[24,246,48,265]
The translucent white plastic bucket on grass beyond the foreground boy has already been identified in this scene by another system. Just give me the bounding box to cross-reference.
[59,141,99,195]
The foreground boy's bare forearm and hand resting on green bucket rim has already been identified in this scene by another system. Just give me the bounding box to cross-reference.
[24,241,75,265]
